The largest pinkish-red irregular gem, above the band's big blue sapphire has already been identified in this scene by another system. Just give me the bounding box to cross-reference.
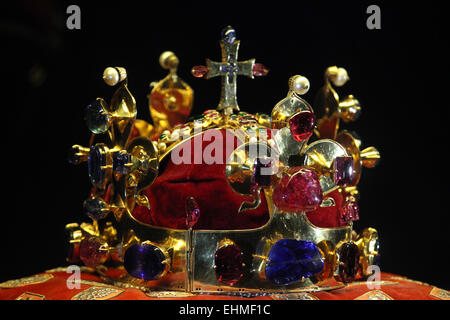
[272,167,323,212]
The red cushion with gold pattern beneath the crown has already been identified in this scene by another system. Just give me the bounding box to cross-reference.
[0,269,450,300]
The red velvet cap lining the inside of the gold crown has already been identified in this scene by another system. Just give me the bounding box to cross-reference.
[133,129,342,230]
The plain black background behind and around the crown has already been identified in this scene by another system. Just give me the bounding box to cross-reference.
[0,1,450,289]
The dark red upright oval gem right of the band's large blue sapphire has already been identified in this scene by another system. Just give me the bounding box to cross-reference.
[337,241,359,283]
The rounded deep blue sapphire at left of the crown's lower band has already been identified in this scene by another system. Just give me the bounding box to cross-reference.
[123,243,166,280]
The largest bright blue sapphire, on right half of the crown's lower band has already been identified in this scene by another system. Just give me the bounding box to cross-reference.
[265,239,324,286]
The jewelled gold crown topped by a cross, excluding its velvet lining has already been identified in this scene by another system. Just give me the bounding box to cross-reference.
[66,27,379,294]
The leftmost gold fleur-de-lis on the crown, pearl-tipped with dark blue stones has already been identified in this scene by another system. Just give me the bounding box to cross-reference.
[69,67,159,226]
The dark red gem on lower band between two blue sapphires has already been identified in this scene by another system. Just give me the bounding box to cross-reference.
[214,244,244,285]
